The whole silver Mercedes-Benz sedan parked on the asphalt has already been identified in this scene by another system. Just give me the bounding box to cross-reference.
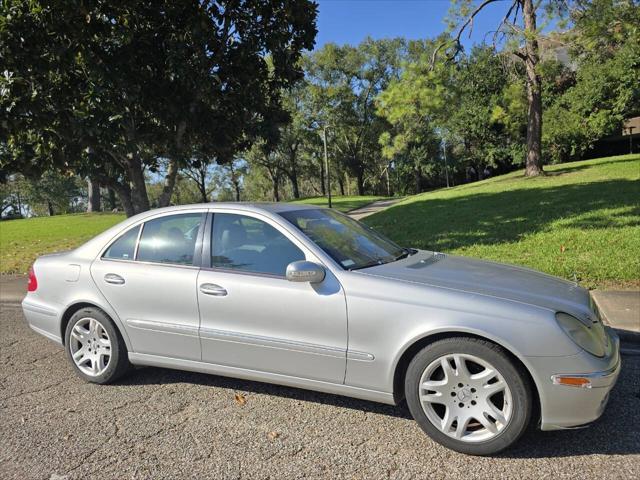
[22,203,621,455]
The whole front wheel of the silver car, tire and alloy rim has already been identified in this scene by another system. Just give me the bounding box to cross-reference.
[405,337,533,455]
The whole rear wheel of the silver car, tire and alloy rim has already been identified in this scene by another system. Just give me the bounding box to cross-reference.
[64,307,131,384]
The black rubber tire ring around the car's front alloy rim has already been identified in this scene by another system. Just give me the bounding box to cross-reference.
[405,337,533,455]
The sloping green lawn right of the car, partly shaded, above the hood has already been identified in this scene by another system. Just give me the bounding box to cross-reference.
[365,155,640,288]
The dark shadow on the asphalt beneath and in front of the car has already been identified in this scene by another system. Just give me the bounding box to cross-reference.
[119,356,640,459]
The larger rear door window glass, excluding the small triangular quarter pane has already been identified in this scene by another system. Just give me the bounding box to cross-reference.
[136,213,202,265]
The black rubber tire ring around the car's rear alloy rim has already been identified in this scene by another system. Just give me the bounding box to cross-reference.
[65,307,130,384]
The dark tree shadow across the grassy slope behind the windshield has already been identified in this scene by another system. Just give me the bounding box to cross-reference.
[366,179,640,251]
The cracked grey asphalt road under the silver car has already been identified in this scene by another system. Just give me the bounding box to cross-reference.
[0,305,640,480]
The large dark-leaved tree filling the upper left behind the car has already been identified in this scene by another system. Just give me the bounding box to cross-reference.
[0,0,316,215]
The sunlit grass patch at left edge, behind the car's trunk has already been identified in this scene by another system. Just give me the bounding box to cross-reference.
[0,213,125,273]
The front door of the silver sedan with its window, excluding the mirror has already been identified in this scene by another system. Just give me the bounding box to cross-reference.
[198,212,347,383]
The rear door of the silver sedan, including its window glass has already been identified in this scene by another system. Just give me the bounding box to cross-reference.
[91,210,206,360]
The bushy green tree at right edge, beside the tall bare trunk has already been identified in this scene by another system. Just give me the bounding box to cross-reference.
[543,0,640,162]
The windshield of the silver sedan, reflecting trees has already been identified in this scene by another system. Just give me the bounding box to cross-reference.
[280,209,404,270]
